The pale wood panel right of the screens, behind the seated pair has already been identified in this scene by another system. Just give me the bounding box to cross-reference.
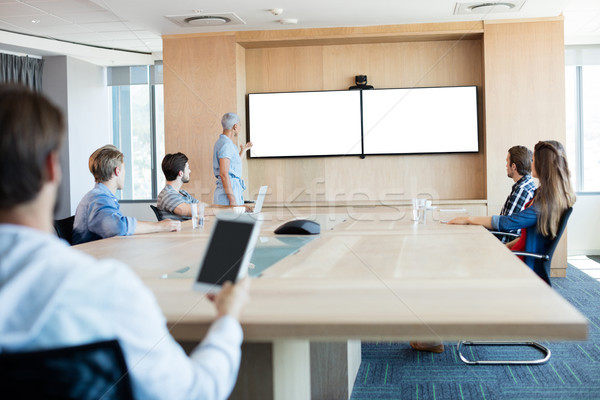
[484,20,566,275]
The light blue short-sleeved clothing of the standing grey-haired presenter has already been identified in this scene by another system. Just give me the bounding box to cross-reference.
[213,134,246,205]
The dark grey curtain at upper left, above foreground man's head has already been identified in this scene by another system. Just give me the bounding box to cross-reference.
[0,53,44,92]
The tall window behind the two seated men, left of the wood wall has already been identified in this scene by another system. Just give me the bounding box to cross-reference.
[107,64,165,200]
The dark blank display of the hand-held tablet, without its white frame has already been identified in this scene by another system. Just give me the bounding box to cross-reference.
[197,220,254,285]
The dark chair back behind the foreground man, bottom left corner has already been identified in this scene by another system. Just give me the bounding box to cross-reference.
[0,340,133,400]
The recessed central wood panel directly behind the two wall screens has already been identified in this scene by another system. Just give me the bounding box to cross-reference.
[246,40,486,204]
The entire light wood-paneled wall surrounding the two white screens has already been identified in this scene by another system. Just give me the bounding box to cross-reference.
[163,18,566,274]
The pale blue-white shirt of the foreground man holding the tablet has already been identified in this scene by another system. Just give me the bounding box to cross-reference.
[0,224,242,399]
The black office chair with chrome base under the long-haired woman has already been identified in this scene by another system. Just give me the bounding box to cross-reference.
[456,207,573,365]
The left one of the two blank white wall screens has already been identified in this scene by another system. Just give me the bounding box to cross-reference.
[248,90,362,158]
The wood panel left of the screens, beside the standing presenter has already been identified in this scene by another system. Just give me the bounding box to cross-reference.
[163,35,244,203]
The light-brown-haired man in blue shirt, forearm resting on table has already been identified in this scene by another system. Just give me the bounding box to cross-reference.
[73,145,181,244]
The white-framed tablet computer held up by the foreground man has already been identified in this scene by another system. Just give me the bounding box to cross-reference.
[194,213,261,293]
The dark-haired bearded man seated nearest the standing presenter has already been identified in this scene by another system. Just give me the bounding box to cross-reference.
[156,153,199,220]
